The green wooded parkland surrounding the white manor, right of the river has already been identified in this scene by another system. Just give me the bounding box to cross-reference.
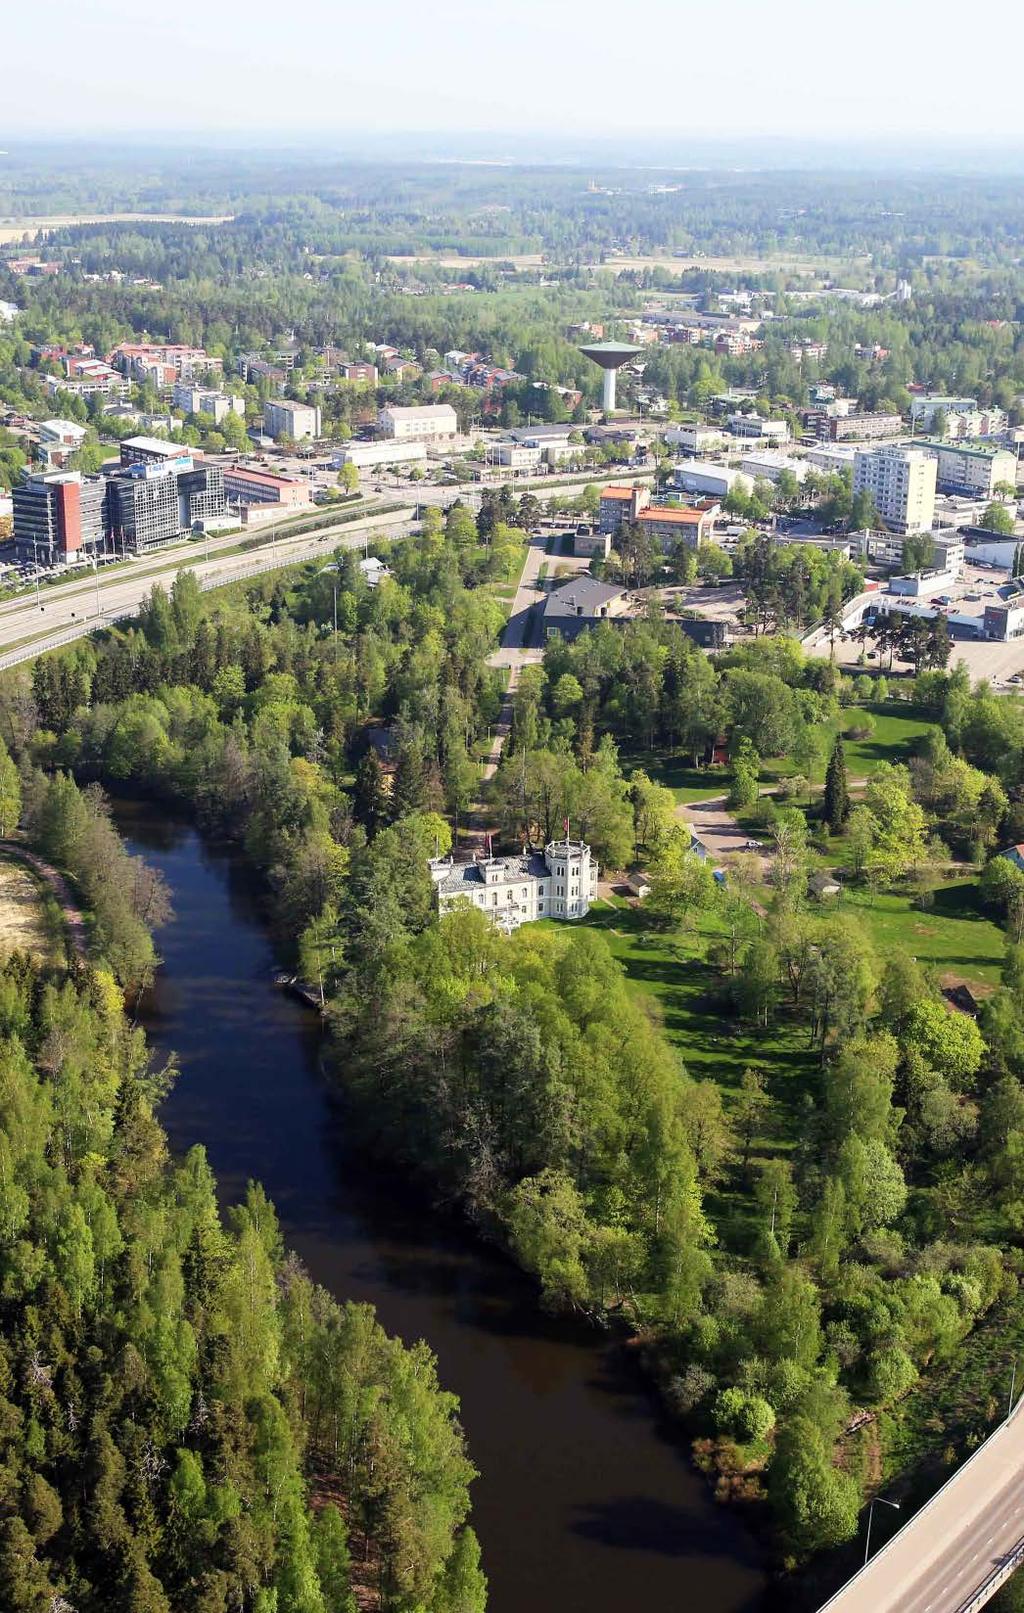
[10,487,1024,1561]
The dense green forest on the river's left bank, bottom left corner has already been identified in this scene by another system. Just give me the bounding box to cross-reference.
[0,941,484,1613]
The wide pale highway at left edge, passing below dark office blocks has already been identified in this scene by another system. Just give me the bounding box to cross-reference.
[0,508,413,668]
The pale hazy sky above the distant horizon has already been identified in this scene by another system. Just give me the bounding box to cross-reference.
[0,0,1024,158]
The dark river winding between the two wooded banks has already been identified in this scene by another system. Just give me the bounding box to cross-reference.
[114,802,766,1613]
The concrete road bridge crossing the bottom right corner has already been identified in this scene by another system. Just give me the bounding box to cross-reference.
[819,1400,1024,1613]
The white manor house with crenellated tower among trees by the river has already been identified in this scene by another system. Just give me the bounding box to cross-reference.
[431,840,597,931]
